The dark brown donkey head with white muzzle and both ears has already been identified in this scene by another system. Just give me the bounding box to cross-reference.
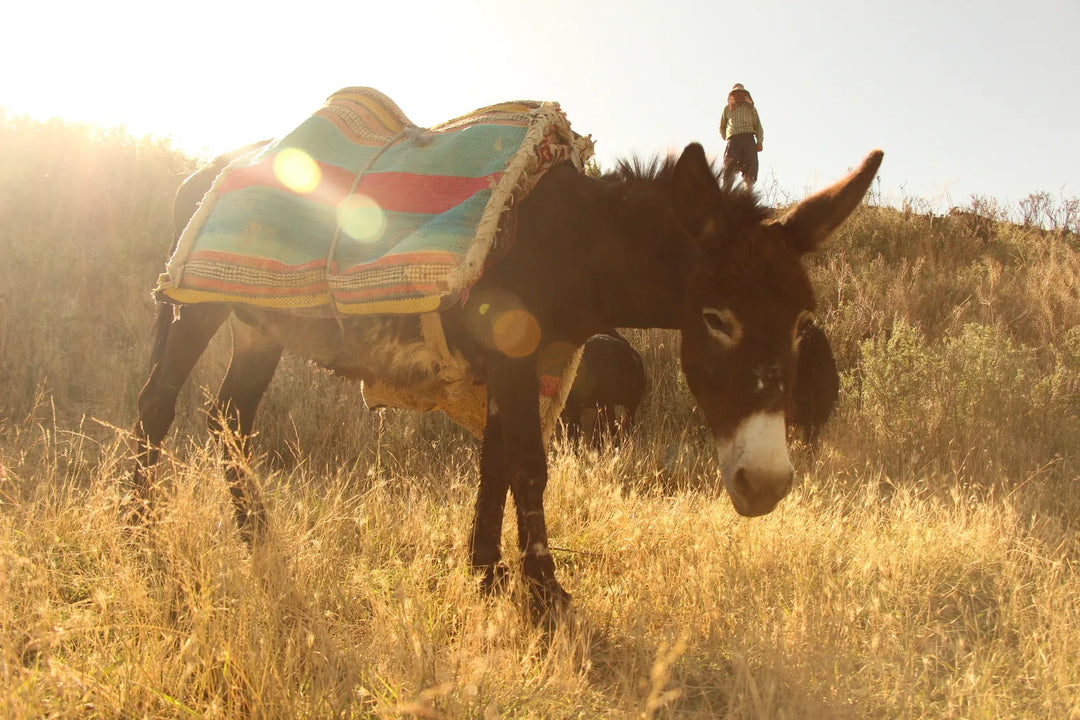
[672,145,882,516]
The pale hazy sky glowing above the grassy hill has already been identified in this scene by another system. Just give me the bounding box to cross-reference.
[0,0,1080,207]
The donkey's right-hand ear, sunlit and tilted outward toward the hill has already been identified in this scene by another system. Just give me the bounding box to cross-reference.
[775,150,885,254]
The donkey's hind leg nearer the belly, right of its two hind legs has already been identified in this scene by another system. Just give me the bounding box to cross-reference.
[208,318,282,544]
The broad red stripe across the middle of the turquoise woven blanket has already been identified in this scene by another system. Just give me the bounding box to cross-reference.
[218,157,501,215]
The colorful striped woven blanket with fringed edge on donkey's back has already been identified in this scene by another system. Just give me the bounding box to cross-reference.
[157,87,592,316]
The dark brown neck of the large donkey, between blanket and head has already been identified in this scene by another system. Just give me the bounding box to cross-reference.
[498,165,690,342]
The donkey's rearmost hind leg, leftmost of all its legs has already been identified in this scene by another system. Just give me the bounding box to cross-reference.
[125,303,229,524]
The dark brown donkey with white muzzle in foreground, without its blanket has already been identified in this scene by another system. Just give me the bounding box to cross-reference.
[134,144,882,608]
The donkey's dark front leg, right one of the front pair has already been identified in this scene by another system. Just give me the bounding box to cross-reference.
[481,358,570,614]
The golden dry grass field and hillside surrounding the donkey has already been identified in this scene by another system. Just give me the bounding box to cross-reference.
[0,112,1080,720]
